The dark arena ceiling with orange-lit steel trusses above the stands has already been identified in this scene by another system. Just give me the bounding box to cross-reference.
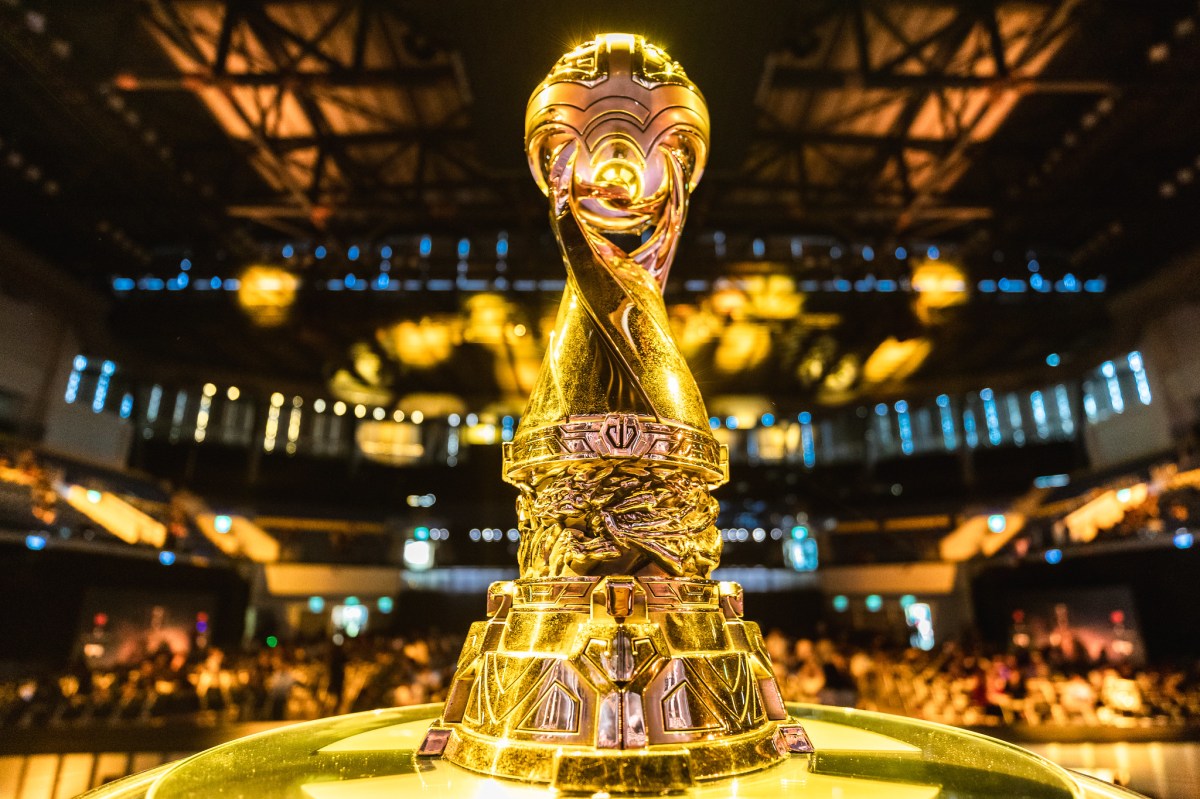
[0,0,1200,402]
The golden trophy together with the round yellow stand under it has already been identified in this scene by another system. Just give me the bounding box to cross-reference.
[88,34,1134,799]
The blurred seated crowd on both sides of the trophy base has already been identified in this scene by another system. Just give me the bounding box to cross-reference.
[0,632,1200,728]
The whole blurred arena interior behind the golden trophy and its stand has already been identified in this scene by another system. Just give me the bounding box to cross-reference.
[0,0,1200,799]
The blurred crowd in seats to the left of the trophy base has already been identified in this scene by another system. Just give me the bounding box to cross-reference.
[0,635,462,728]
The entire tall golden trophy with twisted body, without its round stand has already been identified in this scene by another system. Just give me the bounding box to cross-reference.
[421,34,812,793]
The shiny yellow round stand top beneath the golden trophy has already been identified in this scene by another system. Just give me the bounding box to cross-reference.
[85,704,1138,799]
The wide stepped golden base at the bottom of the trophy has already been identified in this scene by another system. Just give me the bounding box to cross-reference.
[421,575,811,794]
